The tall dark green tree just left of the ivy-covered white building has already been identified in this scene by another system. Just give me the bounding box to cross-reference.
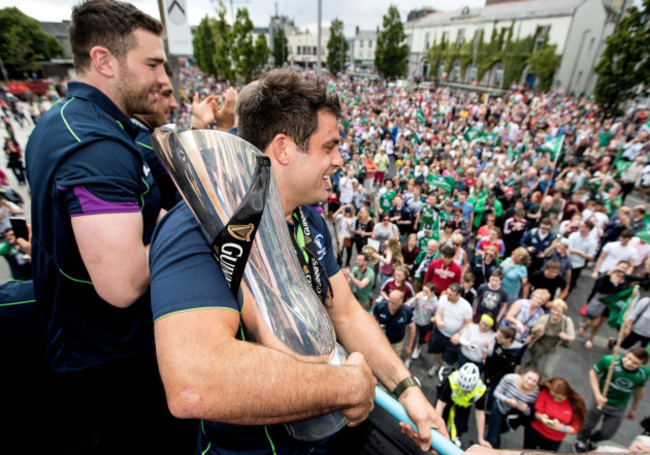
[375,5,409,79]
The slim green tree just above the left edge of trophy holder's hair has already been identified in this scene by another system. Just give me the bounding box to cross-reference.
[231,8,268,83]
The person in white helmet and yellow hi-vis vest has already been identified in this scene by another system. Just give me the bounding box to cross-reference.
[436,363,492,447]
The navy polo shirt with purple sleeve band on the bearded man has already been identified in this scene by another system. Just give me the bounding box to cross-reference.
[25,82,160,372]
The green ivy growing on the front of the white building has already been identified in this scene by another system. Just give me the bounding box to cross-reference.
[427,23,560,88]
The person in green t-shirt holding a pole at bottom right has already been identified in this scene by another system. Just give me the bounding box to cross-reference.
[574,347,650,453]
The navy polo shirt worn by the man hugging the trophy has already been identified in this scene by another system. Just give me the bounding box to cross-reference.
[149,201,339,455]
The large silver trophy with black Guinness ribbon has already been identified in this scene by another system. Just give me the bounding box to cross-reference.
[152,126,347,441]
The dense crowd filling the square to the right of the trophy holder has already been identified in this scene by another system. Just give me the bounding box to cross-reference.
[324,73,650,452]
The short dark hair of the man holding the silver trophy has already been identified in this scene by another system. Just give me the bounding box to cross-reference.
[237,68,341,152]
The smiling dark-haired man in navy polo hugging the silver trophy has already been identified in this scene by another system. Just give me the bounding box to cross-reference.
[150,69,447,454]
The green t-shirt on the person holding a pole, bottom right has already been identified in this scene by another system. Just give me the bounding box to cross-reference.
[593,355,650,408]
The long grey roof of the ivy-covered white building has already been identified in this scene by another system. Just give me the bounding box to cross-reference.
[405,0,585,28]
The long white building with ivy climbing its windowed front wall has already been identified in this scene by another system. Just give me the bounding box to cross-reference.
[404,0,626,93]
